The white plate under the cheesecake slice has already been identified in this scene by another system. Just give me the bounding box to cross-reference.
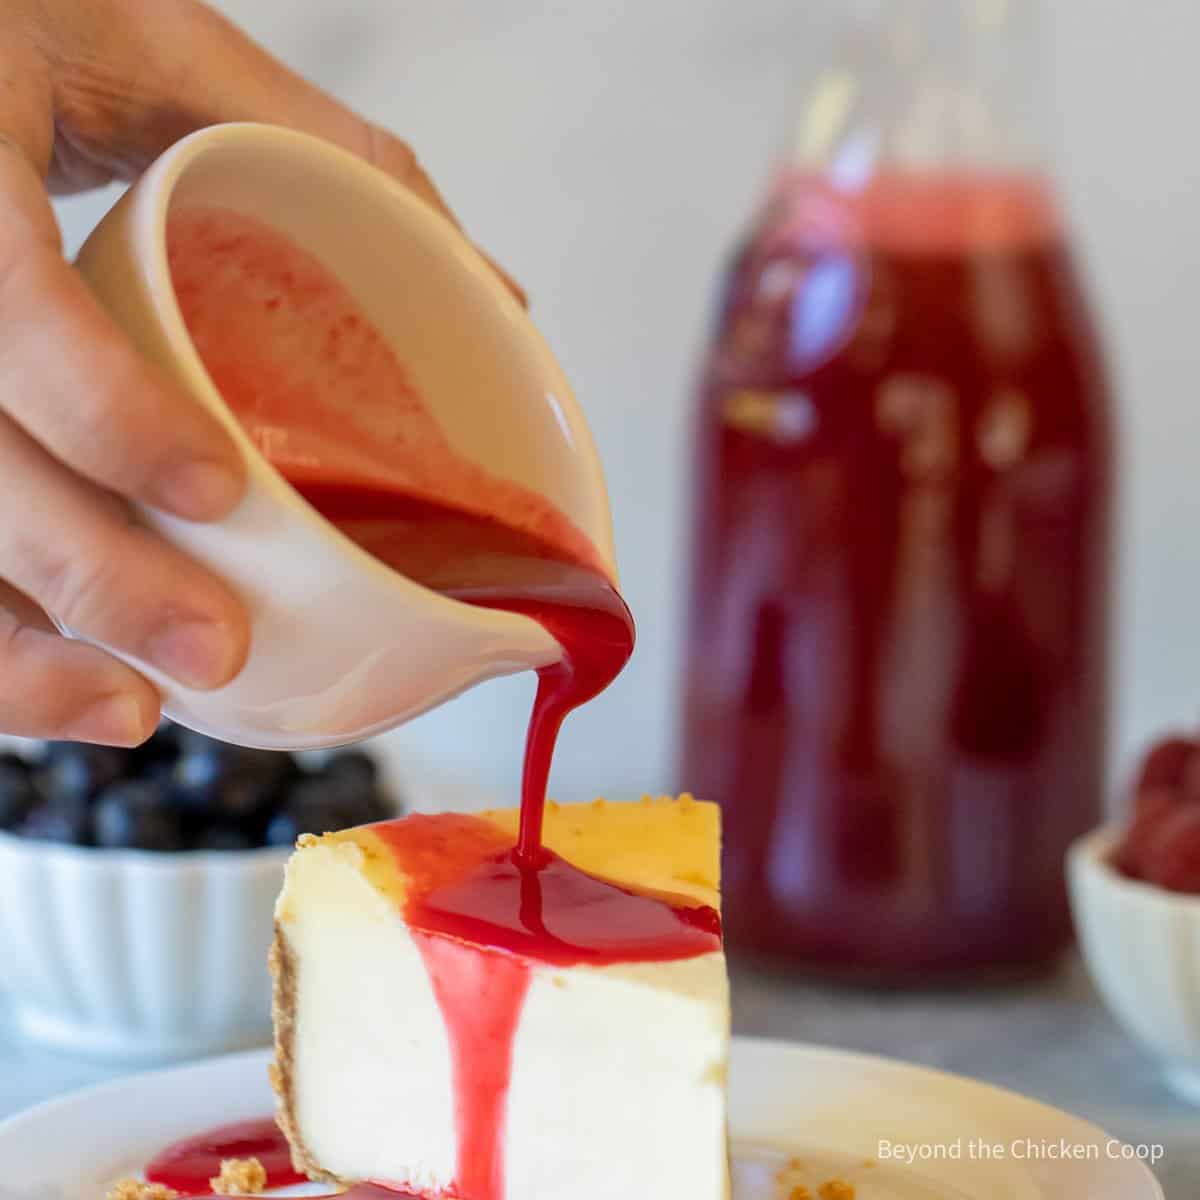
[0,1038,1163,1200]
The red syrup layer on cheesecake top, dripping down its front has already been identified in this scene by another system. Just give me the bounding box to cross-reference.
[350,815,721,1200]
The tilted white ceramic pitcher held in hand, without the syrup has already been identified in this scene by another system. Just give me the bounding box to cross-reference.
[77,125,616,749]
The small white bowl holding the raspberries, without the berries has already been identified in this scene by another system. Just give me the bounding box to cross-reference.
[1067,826,1200,1104]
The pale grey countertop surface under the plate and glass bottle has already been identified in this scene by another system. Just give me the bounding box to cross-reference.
[0,960,1200,1200]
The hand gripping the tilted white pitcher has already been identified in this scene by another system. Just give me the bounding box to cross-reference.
[0,0,520,745]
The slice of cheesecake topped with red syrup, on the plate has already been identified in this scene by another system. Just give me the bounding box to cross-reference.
[272,797,730,1200]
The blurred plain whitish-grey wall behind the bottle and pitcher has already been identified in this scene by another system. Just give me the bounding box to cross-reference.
[54,0,1200,800]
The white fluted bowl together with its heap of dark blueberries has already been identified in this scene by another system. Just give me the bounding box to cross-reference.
[0,722,398,1061]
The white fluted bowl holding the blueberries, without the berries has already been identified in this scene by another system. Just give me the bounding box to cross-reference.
[0,833,289,1061]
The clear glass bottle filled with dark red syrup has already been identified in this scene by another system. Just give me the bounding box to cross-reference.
[680,0,1111,983]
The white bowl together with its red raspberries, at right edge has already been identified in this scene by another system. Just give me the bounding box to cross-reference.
[1068,733,1200,1104]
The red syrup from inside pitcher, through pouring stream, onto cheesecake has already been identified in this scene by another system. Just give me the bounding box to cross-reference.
[168,208,720,1200]
